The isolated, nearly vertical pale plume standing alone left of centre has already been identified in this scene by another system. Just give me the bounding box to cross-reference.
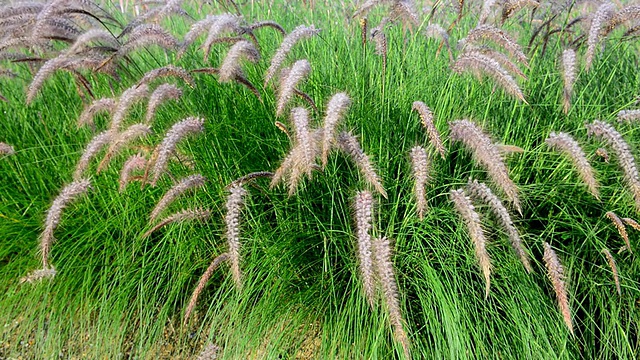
[224,183,247,290]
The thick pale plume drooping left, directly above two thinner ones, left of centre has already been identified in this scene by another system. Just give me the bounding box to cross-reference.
[151,117,204,186]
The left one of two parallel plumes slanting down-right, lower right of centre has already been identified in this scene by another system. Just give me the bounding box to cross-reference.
[449,189,491,299]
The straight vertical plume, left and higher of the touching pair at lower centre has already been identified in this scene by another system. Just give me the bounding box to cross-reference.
[353,190,375,307]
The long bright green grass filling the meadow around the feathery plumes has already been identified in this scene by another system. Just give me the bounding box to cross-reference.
[0,1,640,359]
